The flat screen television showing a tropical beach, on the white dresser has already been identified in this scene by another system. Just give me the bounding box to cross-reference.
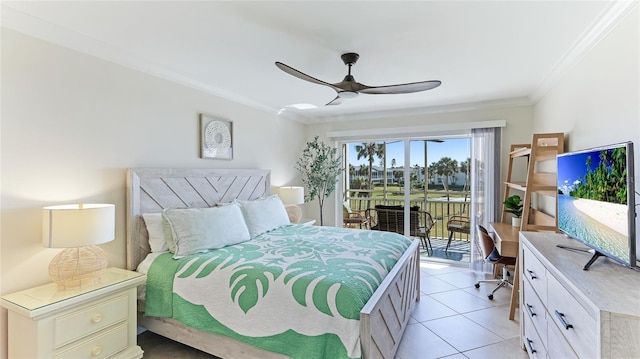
[557,142,637,270]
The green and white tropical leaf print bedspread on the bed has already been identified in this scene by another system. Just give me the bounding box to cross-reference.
[145,225,410,359]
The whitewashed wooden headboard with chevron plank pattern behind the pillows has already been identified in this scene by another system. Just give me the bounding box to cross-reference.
[127,168,271,270]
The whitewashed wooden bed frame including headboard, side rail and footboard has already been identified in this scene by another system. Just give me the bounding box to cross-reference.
[127,168,420,359]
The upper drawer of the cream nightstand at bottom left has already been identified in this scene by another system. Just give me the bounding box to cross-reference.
[54,294,129,348]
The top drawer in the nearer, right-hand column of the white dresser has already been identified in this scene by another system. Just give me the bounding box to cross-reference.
[547,276,598,358]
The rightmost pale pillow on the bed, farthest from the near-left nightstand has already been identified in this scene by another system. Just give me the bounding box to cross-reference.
[236,194,291,238]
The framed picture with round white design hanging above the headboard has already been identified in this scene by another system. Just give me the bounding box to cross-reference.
[200,113,233,160]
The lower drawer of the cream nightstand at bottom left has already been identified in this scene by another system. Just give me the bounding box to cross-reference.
[54,323,129,359]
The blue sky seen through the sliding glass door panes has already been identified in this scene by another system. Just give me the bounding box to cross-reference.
[349,138,471,167]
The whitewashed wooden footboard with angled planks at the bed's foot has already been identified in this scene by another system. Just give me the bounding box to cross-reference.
[360,241,420,359]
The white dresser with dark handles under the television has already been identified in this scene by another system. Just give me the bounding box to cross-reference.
[520,232,640,359]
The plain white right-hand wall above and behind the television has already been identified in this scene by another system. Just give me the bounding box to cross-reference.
[533,7,640,258]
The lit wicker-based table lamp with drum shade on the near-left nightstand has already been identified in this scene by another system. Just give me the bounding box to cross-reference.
[42,204,115,289]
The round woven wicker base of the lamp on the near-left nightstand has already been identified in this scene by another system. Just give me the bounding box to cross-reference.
[49,246,108,289]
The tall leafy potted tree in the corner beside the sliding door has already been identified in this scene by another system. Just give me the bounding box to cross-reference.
[295,136,344,226]
